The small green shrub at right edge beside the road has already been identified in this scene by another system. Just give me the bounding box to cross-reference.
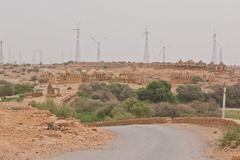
[219,128,240,148]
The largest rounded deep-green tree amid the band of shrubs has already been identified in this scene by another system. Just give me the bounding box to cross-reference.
[136,81,177,103]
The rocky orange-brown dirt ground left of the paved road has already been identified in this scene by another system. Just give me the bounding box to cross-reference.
[0,104,113,160]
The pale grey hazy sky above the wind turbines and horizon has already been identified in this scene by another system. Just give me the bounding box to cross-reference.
[0,0,240,64]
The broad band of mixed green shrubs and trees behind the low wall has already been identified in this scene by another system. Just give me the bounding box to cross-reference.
[31,81,239,122]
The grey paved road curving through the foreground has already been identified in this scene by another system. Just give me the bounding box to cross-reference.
[54,125,212,160]
